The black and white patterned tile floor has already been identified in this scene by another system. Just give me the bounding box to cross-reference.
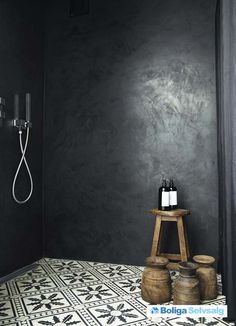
[0,258,232,326]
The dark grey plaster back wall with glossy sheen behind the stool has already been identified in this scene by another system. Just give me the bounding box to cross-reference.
[44,0,218,264]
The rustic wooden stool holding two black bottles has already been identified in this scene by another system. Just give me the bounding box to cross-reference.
[150,208,190,261]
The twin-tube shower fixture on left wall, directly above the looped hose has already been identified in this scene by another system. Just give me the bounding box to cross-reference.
[13,93,32,130]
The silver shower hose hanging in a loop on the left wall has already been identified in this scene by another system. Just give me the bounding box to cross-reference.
[12,128,34,204]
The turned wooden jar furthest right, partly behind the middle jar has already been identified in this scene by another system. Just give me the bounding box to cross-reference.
[193,255,218,300]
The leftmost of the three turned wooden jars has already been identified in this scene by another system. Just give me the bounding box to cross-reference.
[141,256,171,304]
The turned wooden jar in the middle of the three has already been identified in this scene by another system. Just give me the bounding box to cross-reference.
[173,262,200,305]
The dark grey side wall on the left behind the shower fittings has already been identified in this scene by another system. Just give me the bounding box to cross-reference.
[0,0,43,277]
